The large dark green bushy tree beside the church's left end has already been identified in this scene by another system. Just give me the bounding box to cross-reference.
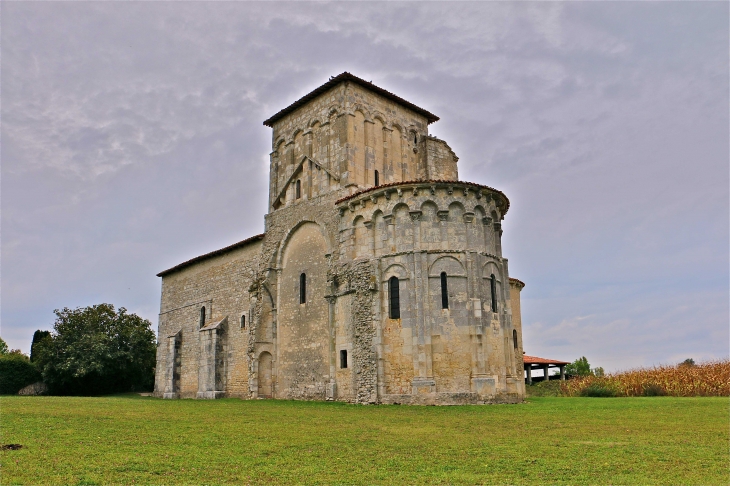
[34,304,156,395]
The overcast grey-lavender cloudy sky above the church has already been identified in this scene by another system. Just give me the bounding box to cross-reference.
[0,2,730,370]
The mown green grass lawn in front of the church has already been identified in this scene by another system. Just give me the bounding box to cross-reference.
[0,396,730,485]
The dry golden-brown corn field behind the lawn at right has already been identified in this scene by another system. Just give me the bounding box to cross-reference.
[561,359,730,397]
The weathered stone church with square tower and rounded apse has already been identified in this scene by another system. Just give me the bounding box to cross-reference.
[155,73,524,405]
